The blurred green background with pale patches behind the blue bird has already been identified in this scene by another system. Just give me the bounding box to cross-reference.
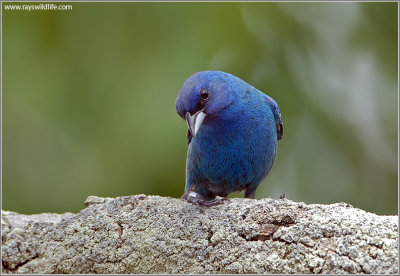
[2,2,398,215]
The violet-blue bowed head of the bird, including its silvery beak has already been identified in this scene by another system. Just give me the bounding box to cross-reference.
[175,71,239,137]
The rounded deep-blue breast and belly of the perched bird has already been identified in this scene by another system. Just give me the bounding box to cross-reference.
[188,113,277,185]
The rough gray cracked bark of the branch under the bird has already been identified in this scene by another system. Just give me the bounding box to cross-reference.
[2,195,398,274]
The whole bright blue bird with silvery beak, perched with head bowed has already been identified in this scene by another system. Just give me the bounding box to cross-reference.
[175,71,283,206]
